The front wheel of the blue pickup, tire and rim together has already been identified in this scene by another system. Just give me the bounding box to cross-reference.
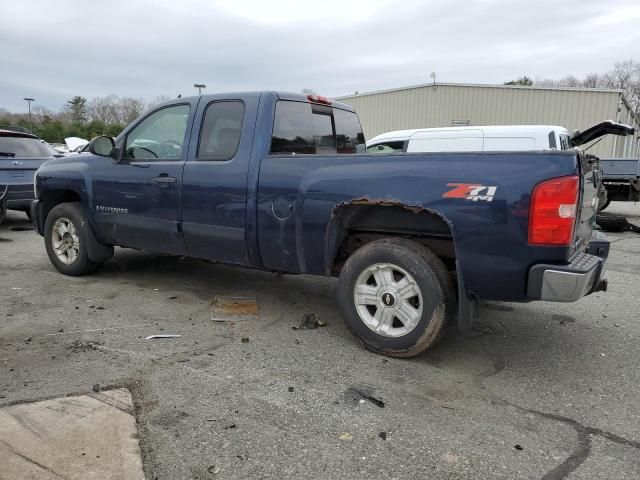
[44,203,100,276]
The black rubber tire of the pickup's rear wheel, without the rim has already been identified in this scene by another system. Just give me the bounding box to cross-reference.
[337,238,456,357]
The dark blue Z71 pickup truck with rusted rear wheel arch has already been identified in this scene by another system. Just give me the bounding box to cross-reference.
[32,91,609,356]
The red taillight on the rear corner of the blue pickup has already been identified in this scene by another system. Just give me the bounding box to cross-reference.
[529,175,580,246]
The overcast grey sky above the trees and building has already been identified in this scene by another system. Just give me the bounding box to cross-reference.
[0,0,640,111]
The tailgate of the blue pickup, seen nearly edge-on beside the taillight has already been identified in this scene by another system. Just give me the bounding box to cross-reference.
[572,152,602,252]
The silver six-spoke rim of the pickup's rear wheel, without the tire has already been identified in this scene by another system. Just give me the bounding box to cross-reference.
[353,263,422,338]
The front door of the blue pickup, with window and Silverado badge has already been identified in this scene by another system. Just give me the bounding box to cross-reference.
[91,100,197,254]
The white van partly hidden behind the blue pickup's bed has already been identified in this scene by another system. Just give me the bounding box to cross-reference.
[367,125,572,154]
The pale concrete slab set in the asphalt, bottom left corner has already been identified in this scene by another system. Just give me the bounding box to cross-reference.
[0,389,144,480]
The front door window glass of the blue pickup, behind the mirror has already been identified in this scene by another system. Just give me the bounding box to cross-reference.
[123,105,190,161]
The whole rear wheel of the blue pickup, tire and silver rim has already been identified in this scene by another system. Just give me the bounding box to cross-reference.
[338,238,455,357]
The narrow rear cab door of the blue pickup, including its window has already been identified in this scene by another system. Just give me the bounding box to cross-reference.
[182,94,260,265]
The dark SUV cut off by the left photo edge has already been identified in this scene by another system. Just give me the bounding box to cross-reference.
[0,129,54,223]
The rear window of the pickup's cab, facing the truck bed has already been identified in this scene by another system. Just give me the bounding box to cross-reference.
[270,100,364,155]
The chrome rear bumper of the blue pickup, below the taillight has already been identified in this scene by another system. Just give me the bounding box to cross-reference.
[527,231,609,302]
